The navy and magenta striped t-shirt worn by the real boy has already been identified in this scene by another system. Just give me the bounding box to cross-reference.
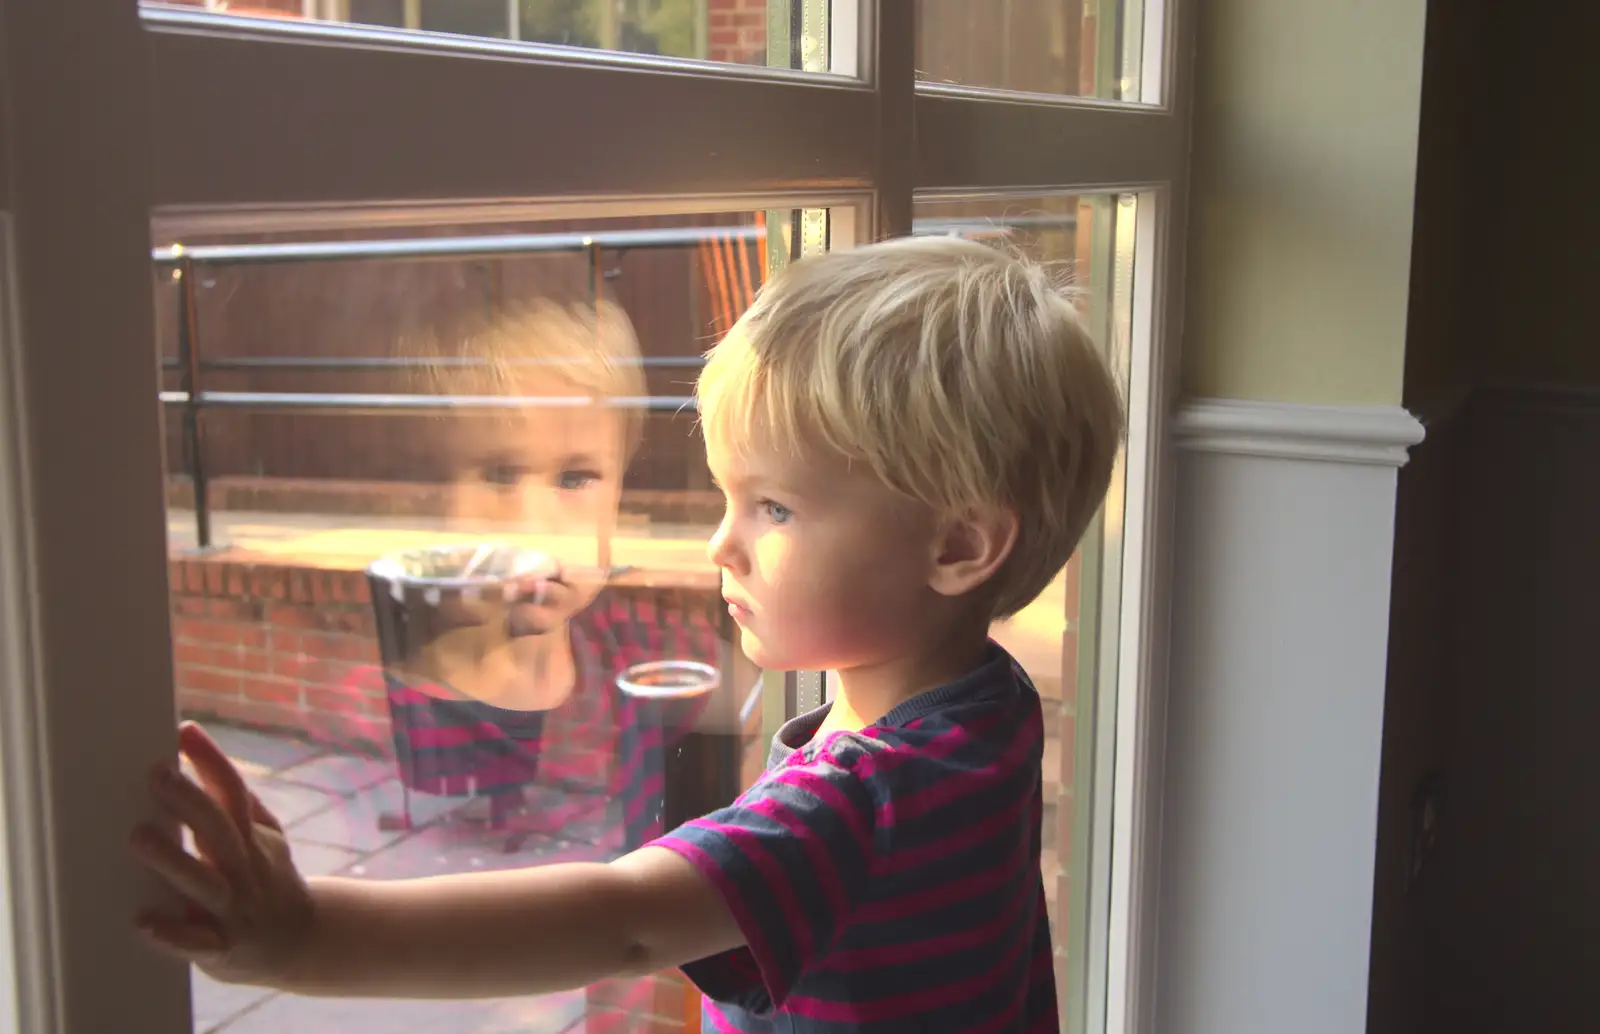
[656,645,1058,1034]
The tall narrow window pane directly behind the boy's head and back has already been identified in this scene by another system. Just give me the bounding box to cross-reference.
[915,195,1136,1031]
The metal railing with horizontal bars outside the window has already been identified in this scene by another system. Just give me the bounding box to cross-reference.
[150,216,1075,549]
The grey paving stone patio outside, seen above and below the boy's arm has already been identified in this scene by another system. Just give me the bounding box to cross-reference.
[194,725,605,1034]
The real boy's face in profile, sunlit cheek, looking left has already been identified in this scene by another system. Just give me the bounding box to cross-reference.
[706,428,938,671]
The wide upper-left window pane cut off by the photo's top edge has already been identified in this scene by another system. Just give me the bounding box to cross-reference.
[146,0,856,75]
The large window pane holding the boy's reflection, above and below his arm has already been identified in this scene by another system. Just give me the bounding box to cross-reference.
[155,204,808,1034]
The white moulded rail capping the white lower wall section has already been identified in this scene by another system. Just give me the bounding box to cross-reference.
[1173,399,1422,467]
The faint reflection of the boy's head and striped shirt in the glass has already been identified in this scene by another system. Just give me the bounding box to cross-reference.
[386,303,739,850]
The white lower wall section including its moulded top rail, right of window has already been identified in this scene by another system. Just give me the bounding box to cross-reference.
[1152,400,1422,1034]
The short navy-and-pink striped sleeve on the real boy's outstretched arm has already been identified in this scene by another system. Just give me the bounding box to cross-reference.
[654,739,877,1012]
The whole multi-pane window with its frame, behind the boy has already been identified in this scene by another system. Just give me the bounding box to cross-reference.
[0,0,1187,1034]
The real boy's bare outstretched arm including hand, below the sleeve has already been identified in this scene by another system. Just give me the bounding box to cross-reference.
[134,725,744,999]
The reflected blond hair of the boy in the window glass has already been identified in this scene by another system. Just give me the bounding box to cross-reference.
[402,299,646,458]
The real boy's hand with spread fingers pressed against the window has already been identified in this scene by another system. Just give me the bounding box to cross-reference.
[131,723,312,984]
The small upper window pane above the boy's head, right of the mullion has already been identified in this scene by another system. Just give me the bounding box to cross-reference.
[917,0,1144,101]
